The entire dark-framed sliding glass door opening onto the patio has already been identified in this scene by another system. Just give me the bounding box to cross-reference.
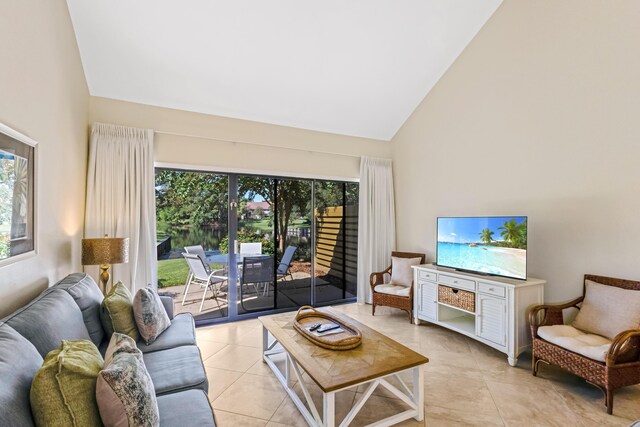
[156,169,358,321]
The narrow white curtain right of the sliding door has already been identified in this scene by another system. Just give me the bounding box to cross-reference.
[358,157,396,304]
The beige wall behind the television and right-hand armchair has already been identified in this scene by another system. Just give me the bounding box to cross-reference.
[392,0,640,301]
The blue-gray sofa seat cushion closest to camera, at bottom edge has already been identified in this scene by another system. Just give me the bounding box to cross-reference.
[158,390,215,427]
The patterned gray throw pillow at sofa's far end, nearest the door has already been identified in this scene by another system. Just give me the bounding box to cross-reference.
[133,286,171,345]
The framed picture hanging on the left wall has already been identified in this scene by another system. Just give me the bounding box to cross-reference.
[0,123,37,267]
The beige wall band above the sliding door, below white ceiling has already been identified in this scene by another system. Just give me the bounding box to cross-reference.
[91,97,391,178]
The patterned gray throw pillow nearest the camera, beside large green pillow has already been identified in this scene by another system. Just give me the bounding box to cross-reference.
[96,332,160,427]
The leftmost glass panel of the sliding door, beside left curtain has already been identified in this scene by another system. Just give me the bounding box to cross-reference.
[155,169,229,321]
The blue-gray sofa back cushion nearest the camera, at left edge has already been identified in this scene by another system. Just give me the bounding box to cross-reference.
[0,322,42,427]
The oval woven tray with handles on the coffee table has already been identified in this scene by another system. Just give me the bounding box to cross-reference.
[293,305,362,350]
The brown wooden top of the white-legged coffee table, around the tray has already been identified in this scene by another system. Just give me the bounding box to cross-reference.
[259,308,429,392]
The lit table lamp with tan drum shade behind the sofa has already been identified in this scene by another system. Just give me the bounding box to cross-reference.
[82,234,129,295]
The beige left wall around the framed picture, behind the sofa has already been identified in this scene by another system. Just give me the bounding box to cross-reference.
[0,0,89,317]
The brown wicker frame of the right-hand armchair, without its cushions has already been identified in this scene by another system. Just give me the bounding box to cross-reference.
[529,275,640,414]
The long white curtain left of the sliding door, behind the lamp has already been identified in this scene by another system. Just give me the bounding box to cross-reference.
[85,123,158,292]
